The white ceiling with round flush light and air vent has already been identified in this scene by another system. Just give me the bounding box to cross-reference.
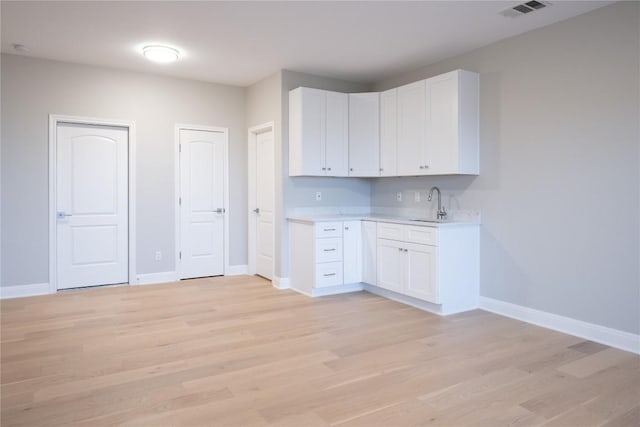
[1,0,612,86]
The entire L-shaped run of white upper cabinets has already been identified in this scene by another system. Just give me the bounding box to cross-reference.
[289,70,480,177]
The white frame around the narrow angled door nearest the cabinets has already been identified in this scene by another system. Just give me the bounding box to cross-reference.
[247,121,276,280]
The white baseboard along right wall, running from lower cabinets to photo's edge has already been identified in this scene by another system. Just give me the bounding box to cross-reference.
[480,297,640,354]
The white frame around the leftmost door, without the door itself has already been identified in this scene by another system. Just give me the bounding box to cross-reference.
[49,114,136,294]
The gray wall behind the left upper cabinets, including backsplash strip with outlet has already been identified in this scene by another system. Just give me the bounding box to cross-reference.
[276,70,371,277]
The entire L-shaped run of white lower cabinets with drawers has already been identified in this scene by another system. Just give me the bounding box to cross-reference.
[289,220,479,314]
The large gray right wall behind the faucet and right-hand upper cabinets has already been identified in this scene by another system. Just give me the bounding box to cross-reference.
[372,2,640,333]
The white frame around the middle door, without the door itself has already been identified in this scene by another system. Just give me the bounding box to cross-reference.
[173,123,231,280]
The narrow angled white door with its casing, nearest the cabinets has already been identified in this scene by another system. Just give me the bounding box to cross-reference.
[248,122,275,280]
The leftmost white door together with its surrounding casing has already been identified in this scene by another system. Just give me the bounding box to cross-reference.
[49,115,135,293]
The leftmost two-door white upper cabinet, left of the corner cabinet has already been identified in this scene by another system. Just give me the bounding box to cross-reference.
[289,87,349,176]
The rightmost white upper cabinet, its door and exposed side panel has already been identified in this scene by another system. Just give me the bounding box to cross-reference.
[426,70,479,175]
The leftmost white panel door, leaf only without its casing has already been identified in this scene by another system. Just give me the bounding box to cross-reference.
[56,123,129,289]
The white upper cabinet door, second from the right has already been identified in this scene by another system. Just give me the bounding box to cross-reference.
[397,80,427,176]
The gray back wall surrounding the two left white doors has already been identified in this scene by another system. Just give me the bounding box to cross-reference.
[0,55,247,286]
